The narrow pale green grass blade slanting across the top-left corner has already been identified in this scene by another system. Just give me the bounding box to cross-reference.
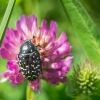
[0,0,16,46]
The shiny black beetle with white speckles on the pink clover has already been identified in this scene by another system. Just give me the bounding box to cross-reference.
[18,40,42,81]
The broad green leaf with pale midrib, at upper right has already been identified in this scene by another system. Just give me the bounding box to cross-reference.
[60,0,100,64]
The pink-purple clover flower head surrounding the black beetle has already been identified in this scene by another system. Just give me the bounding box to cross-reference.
[0,15,73,91]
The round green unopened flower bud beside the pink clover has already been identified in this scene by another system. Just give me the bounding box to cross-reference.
[72,61,100,95]
